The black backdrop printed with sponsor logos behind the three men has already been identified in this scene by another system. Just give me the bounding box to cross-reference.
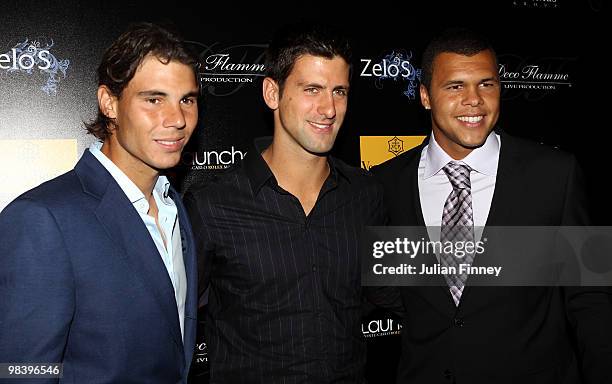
[0,0,612,383]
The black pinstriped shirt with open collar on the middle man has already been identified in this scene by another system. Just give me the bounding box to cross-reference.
[185,139,383,384]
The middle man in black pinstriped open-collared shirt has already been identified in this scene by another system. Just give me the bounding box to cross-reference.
[185,24,382,384]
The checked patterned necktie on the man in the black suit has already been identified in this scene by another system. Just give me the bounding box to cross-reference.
[440,162,474,305]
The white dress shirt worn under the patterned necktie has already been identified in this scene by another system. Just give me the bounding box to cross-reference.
[418,132,501,241]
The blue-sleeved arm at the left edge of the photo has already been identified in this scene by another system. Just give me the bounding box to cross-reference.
[0,199,75,383]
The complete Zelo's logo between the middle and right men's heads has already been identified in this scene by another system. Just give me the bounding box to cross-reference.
[359,50,421,100]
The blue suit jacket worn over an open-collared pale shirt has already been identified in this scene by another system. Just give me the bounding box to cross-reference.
[0,150,197,384]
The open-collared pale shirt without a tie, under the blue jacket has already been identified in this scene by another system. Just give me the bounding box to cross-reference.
[89,141,187,337]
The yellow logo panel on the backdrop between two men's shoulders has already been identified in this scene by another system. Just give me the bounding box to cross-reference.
[359,136,425,169]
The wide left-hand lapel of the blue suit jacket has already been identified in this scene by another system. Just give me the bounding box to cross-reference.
[75,151,183,348]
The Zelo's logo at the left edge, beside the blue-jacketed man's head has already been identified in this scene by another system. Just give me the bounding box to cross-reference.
[0,39,70,96]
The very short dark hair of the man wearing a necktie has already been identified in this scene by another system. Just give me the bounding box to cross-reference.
[421,28,497,89]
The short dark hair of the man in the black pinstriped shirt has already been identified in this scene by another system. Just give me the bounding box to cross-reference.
[265,21,353,94]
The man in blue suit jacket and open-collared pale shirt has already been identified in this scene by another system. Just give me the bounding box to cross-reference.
[0,24,198,384]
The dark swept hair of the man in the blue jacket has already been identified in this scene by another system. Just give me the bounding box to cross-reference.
[85,23,197,141]
